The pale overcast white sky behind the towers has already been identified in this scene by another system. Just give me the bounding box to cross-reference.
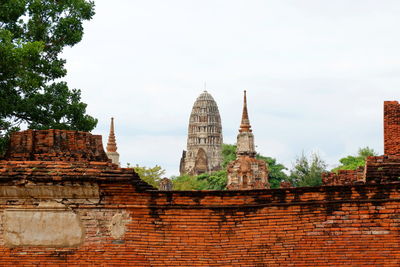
[64,0,400,176]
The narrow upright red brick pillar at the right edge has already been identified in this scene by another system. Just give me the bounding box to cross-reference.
[384,101,400,156]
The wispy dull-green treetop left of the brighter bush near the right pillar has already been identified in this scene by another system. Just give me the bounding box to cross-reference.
[289,152,327,187]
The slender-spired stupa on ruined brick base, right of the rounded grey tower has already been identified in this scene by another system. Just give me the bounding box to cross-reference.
[226,91,270,190]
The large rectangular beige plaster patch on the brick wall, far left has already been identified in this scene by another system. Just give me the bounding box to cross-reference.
[3,210,84,247]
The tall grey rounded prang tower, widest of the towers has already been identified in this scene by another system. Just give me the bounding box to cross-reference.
[180,91,222,175]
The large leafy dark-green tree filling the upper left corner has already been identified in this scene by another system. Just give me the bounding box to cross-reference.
[0,0,97,153]
